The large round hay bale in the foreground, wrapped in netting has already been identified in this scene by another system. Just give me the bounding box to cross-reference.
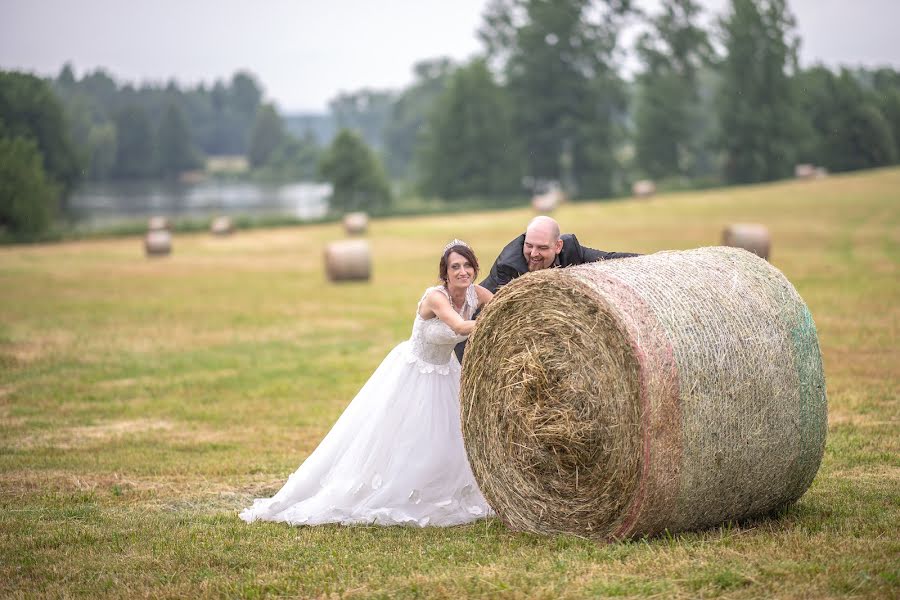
[461,247,827,540]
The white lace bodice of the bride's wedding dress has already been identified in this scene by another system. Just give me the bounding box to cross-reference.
[409,284,478,375]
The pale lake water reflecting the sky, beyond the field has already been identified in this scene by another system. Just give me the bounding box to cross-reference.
[69,180,331,224]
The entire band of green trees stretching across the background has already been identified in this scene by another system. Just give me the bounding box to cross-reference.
[0,0,900,239]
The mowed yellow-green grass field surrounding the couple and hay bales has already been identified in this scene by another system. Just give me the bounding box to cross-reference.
[0,169,900,598]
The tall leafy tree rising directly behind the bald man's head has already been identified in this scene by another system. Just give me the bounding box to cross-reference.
[480,0,631,196]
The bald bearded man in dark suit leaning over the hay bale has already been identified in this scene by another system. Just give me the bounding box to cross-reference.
[456,216,638,363]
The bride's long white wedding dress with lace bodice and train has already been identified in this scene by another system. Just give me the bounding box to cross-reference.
[240,285,494,527]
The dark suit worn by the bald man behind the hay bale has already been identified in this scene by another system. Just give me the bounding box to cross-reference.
[456,233,639,363]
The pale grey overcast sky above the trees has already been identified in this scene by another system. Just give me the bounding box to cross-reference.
[0,0,900,112]
